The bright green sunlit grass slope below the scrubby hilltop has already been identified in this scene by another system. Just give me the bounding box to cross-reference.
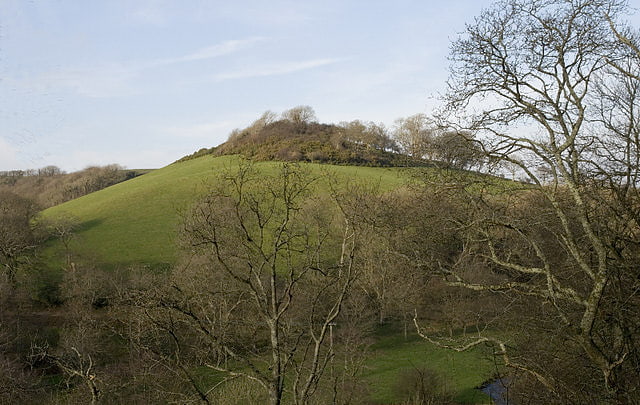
[43,156,405,267]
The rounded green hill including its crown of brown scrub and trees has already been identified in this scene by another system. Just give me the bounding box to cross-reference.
[38,106,484,267]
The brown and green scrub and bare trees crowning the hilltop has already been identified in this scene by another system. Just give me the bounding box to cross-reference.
[178,106,479,168]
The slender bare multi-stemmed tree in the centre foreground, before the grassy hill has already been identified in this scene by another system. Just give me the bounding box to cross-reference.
[147,163,358,404]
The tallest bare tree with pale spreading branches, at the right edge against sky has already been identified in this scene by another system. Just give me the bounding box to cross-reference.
[416,0,640,402]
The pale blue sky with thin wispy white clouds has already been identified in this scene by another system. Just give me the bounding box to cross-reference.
[0,0,636,171]
